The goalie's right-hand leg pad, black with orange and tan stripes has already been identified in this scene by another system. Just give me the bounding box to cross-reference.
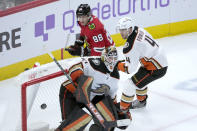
[89,95,131,131]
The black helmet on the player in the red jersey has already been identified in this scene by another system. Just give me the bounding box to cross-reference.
[76,4,91,17]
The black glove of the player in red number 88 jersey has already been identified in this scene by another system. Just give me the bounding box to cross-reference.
[65,45,83,56]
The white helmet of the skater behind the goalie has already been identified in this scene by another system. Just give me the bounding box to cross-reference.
[116,17,134,30]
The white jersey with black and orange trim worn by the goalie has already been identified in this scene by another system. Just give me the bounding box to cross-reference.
[65,57,120,100]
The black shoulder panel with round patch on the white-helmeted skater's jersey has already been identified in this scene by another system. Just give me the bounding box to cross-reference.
[123,26,138,54]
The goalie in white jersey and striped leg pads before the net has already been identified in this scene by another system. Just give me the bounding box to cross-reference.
[56,46,131,131]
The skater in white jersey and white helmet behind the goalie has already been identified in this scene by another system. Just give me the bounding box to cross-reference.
[117,17,168,109]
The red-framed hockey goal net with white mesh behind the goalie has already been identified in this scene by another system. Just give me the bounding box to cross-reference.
[16,59,74,131]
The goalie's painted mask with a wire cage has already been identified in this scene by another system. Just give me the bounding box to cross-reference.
[101,46,118,72]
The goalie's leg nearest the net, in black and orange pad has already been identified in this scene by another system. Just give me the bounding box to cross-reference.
[56,81,92,131]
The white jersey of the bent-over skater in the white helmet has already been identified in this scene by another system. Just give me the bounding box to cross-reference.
[123,26,168,73]
